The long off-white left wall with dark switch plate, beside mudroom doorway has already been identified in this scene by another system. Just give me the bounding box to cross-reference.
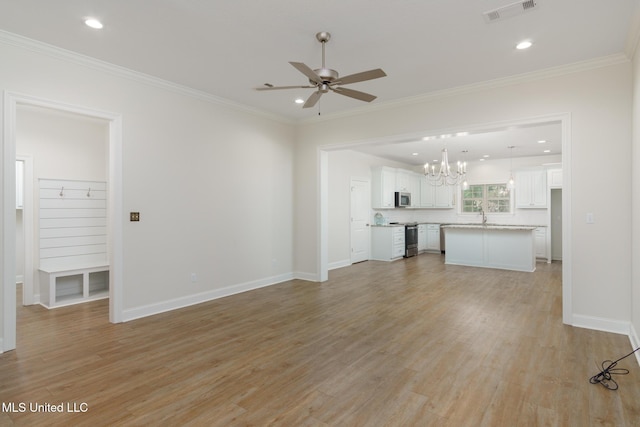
[0,33,294,342]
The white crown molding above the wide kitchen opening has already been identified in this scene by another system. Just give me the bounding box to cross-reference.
[298,53,630,125]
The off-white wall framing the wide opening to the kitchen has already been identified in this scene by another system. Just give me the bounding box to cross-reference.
[295,58,632,328]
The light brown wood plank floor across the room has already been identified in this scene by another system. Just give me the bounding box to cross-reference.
[0,254,640,427]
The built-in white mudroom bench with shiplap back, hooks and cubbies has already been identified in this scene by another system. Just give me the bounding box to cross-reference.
[38,179,109,308]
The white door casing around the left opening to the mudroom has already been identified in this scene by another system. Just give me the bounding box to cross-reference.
[0,91,123,353]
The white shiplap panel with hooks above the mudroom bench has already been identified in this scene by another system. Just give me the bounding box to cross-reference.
[39,179,108,270]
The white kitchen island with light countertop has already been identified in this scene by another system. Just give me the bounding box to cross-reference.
[442,224,537,272]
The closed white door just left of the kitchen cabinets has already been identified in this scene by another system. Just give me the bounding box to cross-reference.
[351,178,371,264]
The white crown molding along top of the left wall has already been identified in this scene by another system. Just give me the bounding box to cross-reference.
[0,30,294,124]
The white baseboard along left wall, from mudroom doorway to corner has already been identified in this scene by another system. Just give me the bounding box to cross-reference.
[122,273,294,322]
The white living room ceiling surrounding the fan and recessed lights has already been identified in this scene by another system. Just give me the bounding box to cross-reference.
[0,0,640,163]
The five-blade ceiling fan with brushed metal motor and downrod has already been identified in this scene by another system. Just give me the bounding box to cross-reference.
[256,31,386,108]
